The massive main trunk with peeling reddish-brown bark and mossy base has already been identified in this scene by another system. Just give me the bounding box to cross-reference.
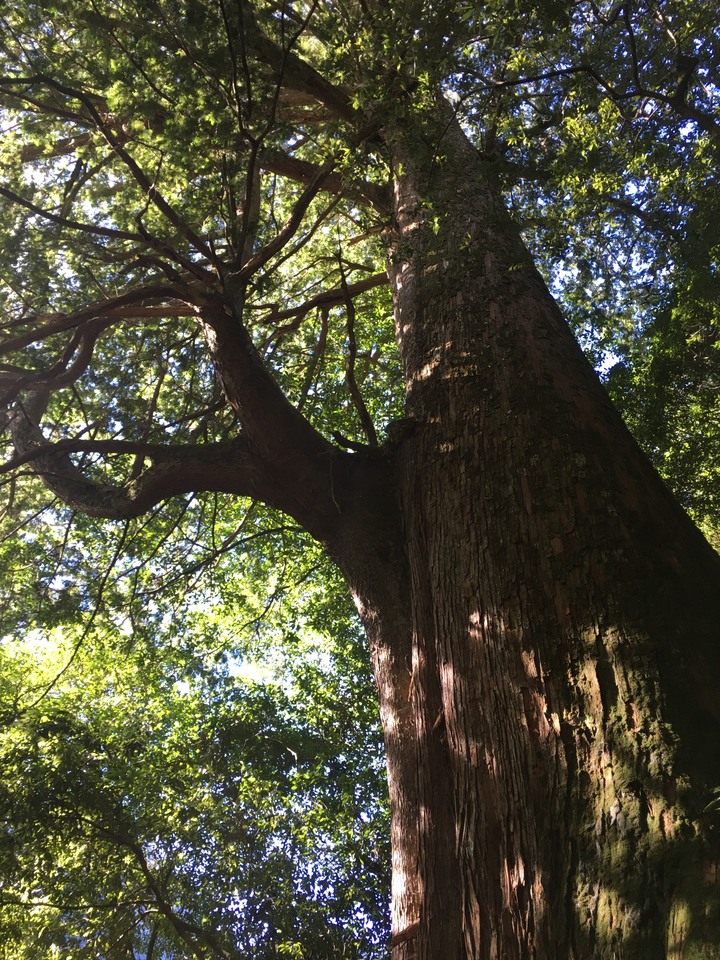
[335,110,720,960]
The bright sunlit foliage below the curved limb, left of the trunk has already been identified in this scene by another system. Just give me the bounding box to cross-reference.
[0,488,389,958]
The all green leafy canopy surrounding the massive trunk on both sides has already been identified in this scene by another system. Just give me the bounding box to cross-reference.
[0,0,720,960]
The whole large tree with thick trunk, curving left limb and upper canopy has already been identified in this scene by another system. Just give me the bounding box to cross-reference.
[0,0,720,960]
